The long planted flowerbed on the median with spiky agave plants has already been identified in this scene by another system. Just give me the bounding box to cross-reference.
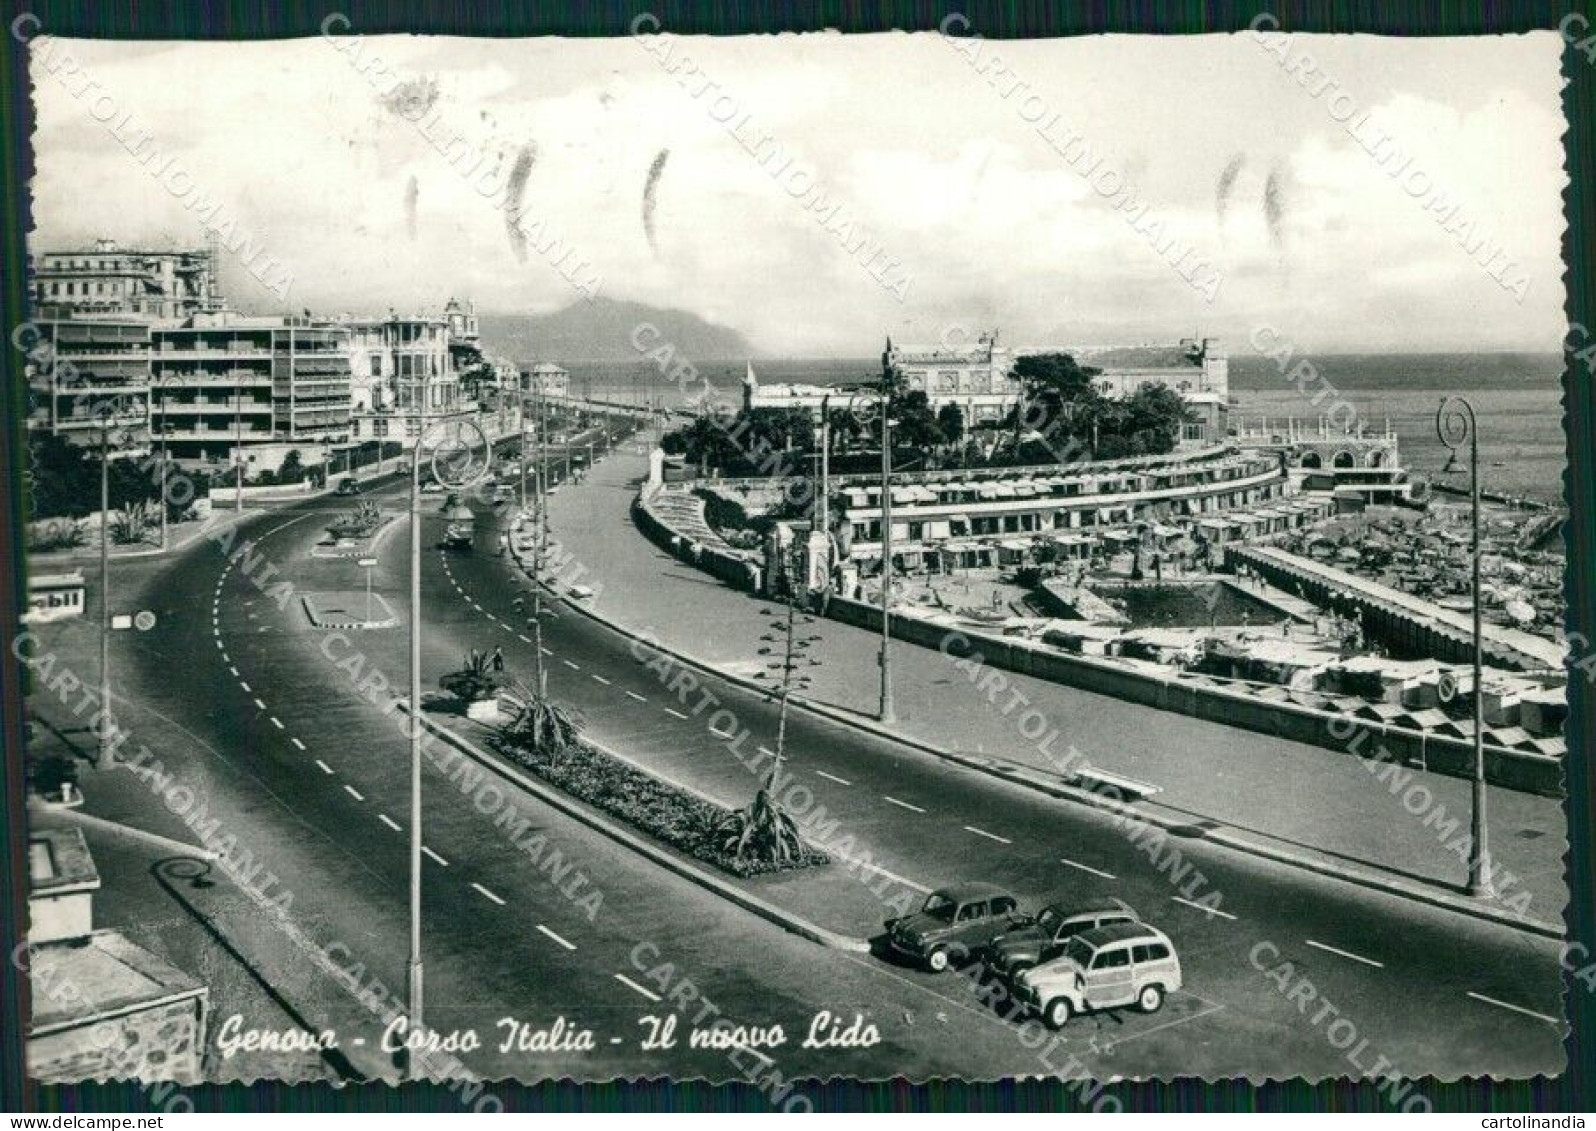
[488,735,830,876]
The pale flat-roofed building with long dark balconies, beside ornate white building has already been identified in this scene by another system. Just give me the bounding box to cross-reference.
[150,311,351,474]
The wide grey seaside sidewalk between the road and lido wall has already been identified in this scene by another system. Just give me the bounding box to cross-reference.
[549,448,1567,922]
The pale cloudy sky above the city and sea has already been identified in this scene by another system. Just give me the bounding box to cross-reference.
[32,29,1564,356]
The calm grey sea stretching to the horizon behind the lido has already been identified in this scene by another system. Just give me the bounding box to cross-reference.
[567,353,1567,504]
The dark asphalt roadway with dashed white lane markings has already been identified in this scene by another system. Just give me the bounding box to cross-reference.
[80,424,1562,1077]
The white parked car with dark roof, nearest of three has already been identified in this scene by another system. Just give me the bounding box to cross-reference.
[1013,924,1181,1029]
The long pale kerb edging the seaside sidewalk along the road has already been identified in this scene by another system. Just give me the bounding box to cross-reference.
[517,532,1567,938]
